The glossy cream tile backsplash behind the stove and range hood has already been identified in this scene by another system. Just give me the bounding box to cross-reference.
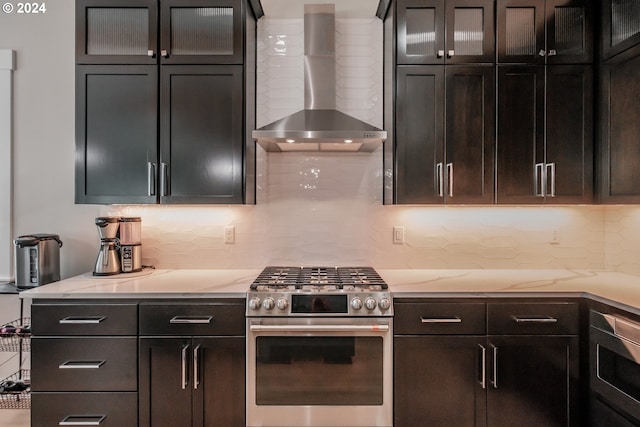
[103,15,640,275]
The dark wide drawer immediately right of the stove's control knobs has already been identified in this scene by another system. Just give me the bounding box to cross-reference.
[393,302,486,335]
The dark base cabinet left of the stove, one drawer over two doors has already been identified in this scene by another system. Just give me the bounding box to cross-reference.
[138,299,246,427]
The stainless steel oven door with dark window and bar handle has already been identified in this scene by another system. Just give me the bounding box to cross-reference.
[247,318,393,427]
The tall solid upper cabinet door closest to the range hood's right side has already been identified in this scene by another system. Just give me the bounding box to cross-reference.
[395,65,445,204]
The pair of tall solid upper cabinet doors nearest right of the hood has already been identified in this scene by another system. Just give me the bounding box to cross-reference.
[395,65,495,204]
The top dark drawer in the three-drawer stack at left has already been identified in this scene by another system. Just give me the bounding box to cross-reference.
[31,304,138,336]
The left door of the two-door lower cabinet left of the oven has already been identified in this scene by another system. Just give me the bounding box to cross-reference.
[138,338,194,427]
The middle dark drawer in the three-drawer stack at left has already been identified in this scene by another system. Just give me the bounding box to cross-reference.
[31,337,138,391]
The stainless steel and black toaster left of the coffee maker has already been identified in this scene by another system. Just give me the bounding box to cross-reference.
[13,233,62,288]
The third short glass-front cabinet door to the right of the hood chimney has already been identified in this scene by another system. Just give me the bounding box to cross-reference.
[497,0,545,64]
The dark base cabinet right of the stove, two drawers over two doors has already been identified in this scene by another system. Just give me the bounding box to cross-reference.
[394,298,580,427]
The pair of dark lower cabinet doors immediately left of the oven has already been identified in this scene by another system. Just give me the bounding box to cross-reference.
[139,337,245,427]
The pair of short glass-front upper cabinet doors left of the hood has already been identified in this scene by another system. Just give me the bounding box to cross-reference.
[76,0,244,64]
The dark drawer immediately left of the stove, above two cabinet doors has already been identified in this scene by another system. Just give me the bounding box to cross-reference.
[140,299,245,336]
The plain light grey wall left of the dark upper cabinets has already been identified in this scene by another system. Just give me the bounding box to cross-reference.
[0,0,100,277]
